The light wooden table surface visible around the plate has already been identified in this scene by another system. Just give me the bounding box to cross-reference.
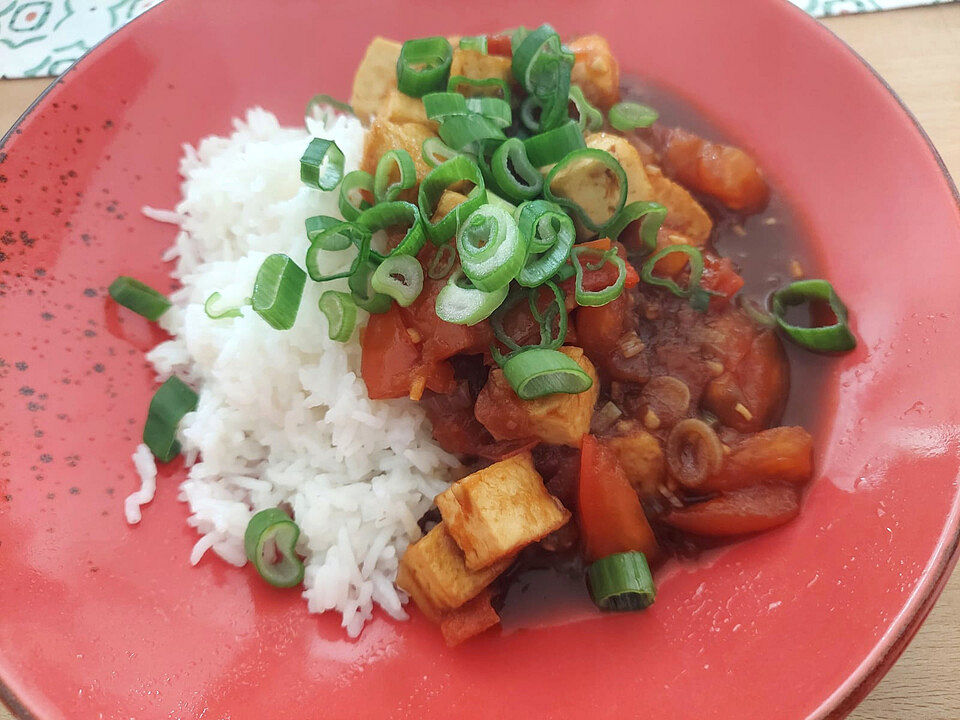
[0,3,960,720]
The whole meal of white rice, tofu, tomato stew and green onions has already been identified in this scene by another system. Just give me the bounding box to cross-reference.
[110,25,856,645]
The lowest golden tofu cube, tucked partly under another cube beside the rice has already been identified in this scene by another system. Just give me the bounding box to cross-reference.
[397,523,513,622]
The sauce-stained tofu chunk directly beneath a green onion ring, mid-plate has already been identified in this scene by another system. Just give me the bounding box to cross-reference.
[474,347,600,447]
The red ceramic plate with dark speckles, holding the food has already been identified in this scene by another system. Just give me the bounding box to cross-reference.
[0,0,960,720]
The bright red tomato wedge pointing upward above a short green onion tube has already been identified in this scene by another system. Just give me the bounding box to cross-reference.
[577,435,658,561]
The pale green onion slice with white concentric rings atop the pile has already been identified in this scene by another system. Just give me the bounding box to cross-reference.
[457,205,527,292]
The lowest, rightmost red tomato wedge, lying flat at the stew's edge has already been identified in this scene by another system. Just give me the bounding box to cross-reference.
[663,485,800,537]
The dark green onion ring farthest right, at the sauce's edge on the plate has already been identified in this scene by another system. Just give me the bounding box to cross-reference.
[772,280,857,352]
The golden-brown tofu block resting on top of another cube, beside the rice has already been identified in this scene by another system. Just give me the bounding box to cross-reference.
[436,452,570,570]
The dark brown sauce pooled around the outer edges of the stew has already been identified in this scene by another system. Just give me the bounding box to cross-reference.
[498,78,831,632]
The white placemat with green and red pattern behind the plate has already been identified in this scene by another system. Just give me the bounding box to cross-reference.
[0,0,952,78]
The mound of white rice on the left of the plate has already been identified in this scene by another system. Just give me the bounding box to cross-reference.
[129,109,458,637]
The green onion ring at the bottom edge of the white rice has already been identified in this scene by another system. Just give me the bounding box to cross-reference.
[243,508,303,588]
